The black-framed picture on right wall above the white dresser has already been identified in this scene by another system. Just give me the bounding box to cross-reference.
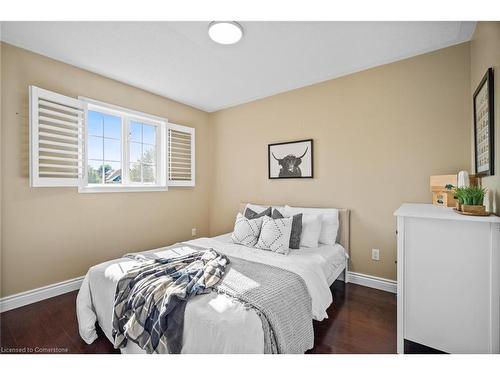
[473,68,495,176]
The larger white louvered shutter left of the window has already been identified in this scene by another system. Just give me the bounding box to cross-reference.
[30,86,84,187]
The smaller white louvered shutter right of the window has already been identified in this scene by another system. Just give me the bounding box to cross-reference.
[168,124,195,186]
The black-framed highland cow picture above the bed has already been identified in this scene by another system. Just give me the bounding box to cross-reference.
[267,139,313,179]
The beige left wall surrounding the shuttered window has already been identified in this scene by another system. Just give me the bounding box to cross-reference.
[1,44,210,296]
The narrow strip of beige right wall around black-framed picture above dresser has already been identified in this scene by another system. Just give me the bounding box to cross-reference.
[470,22,500,214]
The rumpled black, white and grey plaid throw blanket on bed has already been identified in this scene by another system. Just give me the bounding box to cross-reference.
[113,249,229,353]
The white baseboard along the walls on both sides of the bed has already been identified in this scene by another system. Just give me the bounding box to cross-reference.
[0,271,397,312]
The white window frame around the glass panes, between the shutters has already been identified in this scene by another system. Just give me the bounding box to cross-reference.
[78,96,169,193]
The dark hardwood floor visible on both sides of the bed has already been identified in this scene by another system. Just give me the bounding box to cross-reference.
[0,281,396,354]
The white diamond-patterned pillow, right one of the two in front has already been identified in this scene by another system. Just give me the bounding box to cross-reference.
[255,216,293,255]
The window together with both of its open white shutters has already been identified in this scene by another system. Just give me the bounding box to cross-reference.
[30,86,195,193]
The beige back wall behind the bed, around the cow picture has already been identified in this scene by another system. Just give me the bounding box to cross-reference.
[210,43,471,279]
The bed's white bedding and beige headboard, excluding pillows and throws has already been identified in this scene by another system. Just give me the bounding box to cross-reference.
[77,204,349,353]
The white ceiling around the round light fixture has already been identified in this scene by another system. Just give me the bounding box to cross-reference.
[1,22,475,112]
